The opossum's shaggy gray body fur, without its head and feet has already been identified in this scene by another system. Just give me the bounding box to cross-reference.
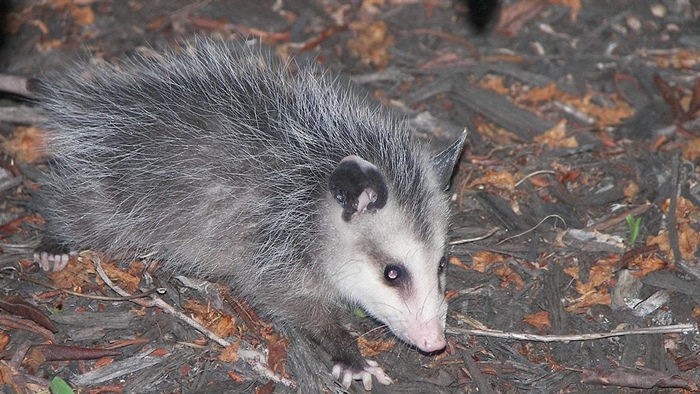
[36,40,460,390]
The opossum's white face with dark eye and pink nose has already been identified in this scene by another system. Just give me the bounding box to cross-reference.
[327,203,447,352]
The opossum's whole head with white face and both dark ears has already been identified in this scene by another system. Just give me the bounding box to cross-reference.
[326,134,466,352]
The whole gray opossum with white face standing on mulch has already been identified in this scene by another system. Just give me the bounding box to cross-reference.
[34,39,466,389]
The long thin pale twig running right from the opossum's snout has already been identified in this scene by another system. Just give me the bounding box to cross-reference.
[445,324,698,342]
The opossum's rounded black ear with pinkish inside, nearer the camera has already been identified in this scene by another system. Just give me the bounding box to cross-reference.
[328,156,389,221]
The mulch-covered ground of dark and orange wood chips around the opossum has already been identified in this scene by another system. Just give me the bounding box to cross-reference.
[0,0,700,393]
